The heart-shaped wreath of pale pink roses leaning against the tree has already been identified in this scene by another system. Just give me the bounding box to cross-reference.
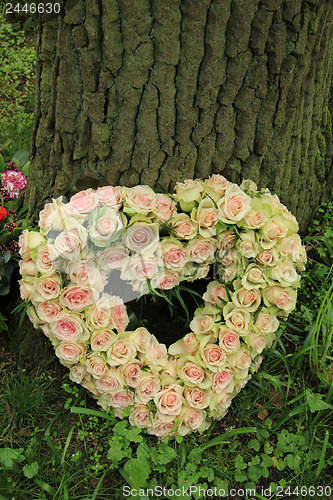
[20,174,306,437]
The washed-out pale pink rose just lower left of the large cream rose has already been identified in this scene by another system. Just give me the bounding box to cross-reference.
[54,223,87,260]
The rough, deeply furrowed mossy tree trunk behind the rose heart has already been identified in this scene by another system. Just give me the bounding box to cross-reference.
[27,0,333,229]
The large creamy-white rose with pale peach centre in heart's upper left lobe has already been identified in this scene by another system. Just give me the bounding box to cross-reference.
[89,207,123,247]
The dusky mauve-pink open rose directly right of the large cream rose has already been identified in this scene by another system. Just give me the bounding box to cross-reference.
[125,222,160,252]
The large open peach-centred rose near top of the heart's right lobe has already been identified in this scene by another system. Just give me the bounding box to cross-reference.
[217,184,251,224]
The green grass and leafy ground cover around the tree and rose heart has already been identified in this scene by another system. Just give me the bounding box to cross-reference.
[0,11,333,500]
